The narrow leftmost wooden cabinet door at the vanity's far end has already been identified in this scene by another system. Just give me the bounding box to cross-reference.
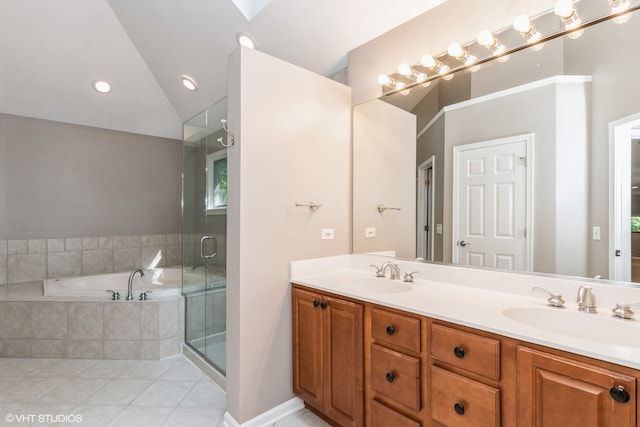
[292,288,324,410]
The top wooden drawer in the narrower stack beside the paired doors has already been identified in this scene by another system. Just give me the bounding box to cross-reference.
[371,308,420,353]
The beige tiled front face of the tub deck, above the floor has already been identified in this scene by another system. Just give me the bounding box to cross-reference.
[0,283,184,360]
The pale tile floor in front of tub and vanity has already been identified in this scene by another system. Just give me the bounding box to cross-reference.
[0,355,328,427]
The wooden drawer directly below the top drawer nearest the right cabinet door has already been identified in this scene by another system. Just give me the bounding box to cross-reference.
[430,366,500,427]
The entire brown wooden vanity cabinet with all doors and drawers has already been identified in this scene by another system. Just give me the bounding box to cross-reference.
[293,285,640,427]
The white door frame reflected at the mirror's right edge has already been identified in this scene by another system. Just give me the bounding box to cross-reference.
[609,113,640,282]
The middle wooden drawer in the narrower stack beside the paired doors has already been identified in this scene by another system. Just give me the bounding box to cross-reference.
[371,344,421,411]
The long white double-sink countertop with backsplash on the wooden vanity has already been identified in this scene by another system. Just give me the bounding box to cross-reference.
[290,255,640,369]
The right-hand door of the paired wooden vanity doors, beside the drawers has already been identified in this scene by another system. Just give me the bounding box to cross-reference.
[322,298,364,426]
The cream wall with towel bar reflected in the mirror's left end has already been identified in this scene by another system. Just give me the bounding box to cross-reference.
[353,100,416,259]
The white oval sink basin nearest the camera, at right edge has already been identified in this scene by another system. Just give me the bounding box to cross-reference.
[502,307,640,347]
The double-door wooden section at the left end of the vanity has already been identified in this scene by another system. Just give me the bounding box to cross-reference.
[292,287,364,426]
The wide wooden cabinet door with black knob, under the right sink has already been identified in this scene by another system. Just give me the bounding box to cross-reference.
[517,347,636,427]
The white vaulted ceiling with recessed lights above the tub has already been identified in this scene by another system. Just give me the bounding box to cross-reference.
[0,0,445,139]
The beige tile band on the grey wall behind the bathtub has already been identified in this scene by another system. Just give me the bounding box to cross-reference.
[0,234,182,285]
